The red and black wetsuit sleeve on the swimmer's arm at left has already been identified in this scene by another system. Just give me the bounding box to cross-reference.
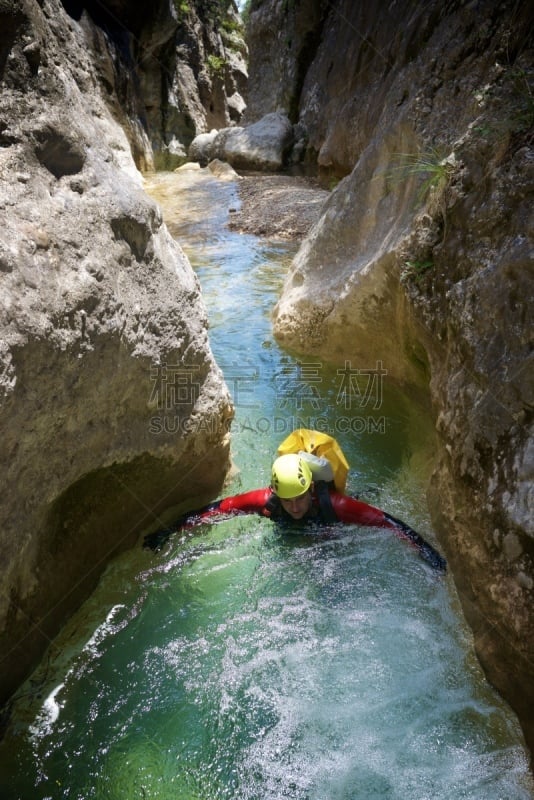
[143,488,272,550]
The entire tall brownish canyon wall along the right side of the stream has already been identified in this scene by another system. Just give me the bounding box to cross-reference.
[247,0,534,746]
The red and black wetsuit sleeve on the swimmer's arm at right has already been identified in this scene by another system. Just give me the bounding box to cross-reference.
[330,492,447,572]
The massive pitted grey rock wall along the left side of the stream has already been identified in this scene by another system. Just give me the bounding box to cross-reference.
[0,0,232,699]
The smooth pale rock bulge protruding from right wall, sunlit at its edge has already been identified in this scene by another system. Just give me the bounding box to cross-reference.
[273,123,428,383]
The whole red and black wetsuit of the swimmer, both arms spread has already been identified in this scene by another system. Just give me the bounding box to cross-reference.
[145,482,446,572]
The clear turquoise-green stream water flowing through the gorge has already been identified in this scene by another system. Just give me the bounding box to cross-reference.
[0,170,534,800]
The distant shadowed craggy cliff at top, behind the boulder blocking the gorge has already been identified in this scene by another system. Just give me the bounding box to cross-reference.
[57,0,248,170]
